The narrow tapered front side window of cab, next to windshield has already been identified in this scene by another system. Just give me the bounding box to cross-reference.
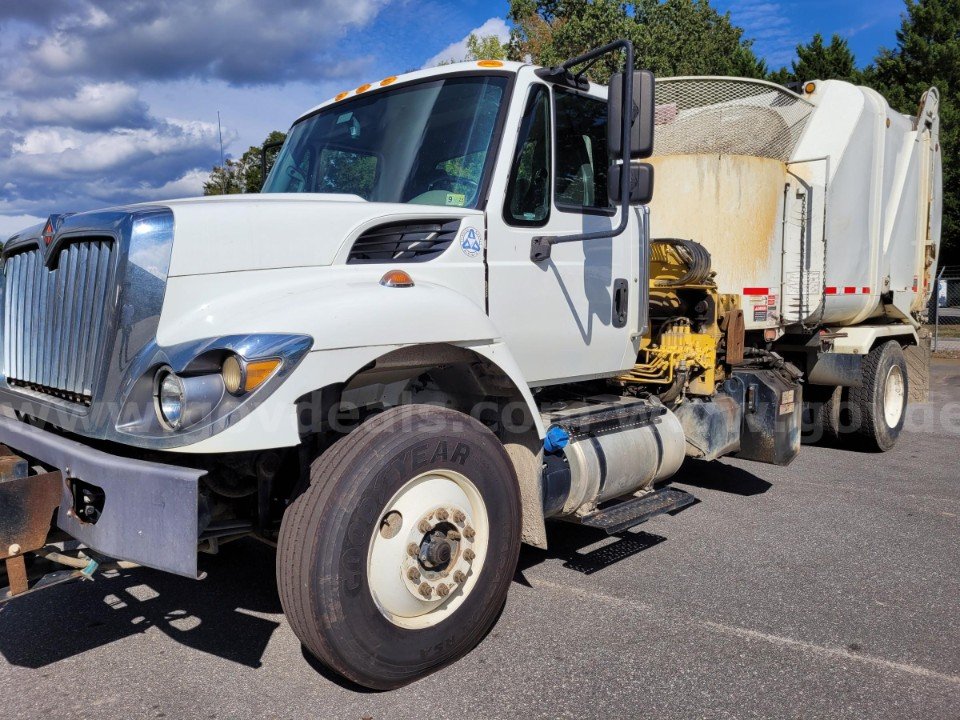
[503,85,550,226]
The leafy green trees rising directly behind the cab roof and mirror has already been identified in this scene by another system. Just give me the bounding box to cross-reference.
[508,0,767,82]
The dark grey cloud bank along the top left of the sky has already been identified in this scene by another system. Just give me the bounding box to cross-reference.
[0,0,388,85]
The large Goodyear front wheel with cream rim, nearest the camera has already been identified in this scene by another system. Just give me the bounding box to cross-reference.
[277,405,521,690]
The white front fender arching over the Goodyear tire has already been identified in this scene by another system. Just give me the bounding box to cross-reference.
[157,266,545,453]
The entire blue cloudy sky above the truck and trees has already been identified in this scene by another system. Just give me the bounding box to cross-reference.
[0,0,903,239]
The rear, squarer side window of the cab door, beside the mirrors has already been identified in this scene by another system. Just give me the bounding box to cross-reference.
[554,88,610,211]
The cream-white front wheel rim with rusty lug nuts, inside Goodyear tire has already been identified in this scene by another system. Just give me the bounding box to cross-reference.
[367,470,490,629]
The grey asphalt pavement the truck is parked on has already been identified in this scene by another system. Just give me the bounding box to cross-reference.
[0,360,960,720]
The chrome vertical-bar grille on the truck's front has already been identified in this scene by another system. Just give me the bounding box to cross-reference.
[3,238,115,405]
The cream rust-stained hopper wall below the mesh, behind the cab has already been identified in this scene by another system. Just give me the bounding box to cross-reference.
[649,155,786,293]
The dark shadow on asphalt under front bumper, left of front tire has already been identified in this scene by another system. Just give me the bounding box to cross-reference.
[0,541,282,668]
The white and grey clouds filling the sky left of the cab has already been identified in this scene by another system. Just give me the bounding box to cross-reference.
[0,0,394,219]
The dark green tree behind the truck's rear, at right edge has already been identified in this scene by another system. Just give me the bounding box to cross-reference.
[865,0,960,265]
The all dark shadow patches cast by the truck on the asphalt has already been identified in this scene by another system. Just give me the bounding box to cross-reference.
[0,460,770,676]
